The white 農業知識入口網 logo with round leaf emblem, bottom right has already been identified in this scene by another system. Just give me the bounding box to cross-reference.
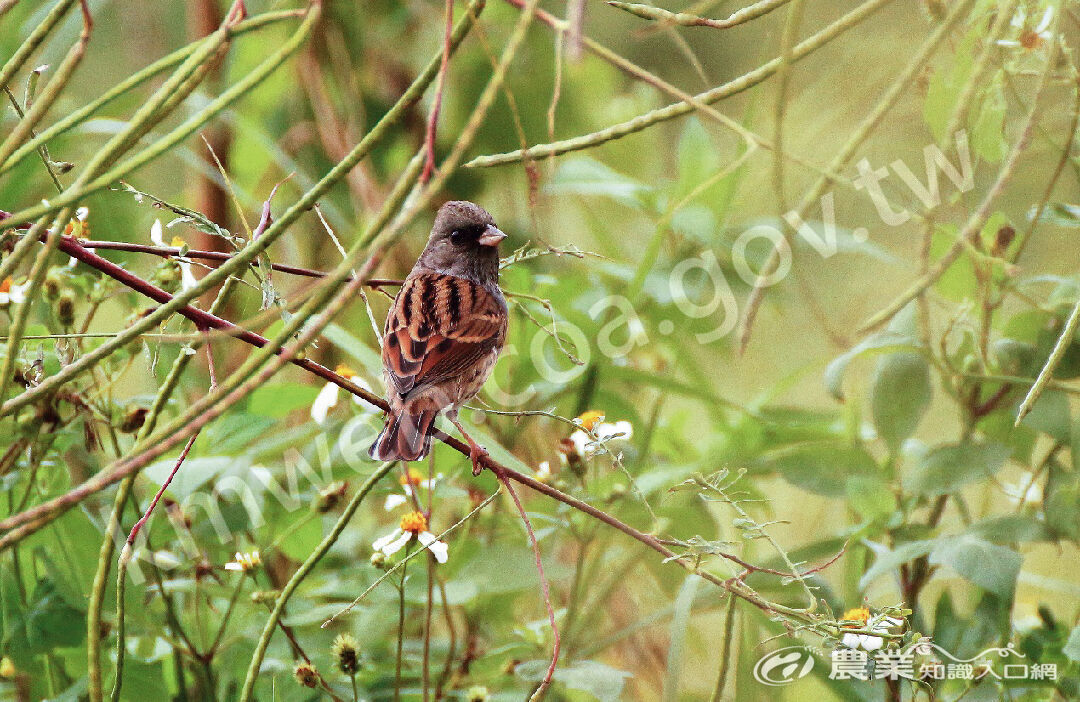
[753,639,1057,687]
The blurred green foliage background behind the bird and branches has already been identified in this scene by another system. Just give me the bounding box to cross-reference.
[0,0,1080,701]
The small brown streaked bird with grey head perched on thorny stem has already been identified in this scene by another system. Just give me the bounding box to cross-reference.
[368,200,509,475]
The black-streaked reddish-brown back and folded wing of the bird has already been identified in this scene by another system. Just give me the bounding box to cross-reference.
[382,268,507,397]
